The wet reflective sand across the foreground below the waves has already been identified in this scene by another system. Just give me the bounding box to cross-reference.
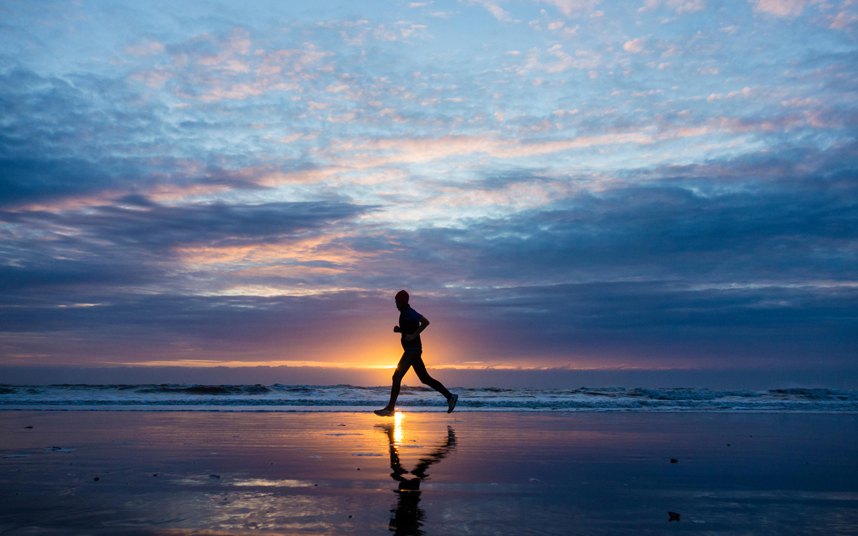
[0,411,858,535]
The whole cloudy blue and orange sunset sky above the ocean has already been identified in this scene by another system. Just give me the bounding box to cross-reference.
[0,0,858,388]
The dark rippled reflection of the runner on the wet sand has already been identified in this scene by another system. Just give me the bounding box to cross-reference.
[377,412,456,534]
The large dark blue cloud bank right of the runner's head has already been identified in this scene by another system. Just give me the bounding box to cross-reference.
[348,144,858,363]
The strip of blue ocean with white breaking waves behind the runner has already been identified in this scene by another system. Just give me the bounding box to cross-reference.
[0,384,858,413]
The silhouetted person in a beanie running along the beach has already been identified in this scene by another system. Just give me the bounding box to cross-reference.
[375,290,459,417]
